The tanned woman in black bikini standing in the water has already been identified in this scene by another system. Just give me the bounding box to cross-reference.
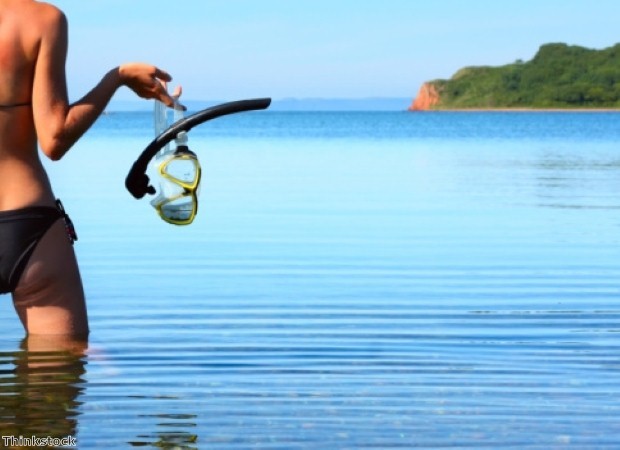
[0,0,179,336]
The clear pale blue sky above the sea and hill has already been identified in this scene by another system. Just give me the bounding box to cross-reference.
[52,0,620,100]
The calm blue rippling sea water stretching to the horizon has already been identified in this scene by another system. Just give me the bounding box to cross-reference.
[0,111,620,449]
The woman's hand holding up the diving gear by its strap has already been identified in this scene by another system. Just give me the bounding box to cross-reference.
[118,63,180,108]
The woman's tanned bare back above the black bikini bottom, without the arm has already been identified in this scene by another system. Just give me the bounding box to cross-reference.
[0,0,54,211]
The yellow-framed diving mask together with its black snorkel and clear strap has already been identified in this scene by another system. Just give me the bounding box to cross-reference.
[125,98,271,225]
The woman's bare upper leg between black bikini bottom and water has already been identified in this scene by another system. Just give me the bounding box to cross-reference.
[13,220,88,336]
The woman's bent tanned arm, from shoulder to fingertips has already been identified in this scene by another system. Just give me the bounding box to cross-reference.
[32,5,173,160]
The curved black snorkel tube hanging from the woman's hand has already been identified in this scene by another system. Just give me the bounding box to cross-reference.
[125,98,271,199]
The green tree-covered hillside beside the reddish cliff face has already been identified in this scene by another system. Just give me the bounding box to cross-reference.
[431,44,620,109]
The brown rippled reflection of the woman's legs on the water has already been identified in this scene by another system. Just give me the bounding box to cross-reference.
[0,336,88,448]
